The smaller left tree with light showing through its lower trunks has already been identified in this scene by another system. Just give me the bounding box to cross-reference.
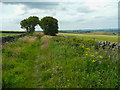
[20,16,39,33]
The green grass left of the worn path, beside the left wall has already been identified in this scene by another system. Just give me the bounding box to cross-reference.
[2,33,40,88]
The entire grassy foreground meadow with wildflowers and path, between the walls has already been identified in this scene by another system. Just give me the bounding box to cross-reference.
[0,33,120,88]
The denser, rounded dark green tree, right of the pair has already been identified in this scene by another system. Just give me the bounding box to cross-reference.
[39,16,58,36]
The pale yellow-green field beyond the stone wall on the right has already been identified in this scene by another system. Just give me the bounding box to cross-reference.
[58,33,120,42]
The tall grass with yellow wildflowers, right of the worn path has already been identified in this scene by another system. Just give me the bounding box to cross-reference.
[36,38,119,88]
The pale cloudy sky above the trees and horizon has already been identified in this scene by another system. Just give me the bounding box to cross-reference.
[0,0,119,31]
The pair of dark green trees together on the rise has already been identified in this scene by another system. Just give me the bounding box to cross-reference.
[20,16,58,36]
